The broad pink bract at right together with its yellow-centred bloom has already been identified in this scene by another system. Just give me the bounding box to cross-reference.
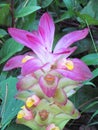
[57,58,92,81]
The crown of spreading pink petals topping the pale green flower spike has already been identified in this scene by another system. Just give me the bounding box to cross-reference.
[4,13,92,81]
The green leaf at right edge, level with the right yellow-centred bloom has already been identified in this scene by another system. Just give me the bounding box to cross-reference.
[82,53,98,65]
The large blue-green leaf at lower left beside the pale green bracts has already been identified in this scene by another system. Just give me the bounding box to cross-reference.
[0,77,23,130]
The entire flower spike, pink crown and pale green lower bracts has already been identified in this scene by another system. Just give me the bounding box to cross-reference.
[4,13,92,130]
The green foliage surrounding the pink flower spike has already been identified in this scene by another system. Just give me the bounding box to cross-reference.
[0,0,98,130]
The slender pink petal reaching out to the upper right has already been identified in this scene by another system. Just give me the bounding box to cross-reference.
[54,28,88,53]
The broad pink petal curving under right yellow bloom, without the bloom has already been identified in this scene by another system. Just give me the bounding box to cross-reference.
[57,58,92,81]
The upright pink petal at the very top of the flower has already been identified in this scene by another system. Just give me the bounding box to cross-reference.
[38,13,55,52]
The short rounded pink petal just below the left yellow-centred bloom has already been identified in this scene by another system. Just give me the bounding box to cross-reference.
[21,59,43,76]
